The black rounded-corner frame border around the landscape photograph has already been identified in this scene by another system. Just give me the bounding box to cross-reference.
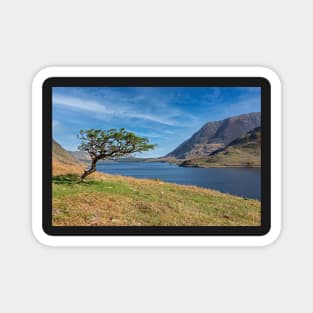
[42,77,271,236]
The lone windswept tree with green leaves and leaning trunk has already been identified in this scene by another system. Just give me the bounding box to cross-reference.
[77,128,156,180]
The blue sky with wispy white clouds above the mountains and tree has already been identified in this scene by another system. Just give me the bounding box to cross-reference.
[52,87,261,157]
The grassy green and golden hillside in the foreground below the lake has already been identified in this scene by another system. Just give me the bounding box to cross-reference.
[53,160,261,226]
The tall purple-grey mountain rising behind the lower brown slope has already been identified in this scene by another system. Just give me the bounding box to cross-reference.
[166,112,261,159]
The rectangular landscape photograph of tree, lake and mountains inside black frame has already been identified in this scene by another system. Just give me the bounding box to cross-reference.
[51,86,262,227]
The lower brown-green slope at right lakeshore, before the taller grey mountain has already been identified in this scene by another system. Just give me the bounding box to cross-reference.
[181,127,261,167]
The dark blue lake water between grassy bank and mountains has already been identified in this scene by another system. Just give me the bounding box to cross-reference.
[97,162,261,199]
